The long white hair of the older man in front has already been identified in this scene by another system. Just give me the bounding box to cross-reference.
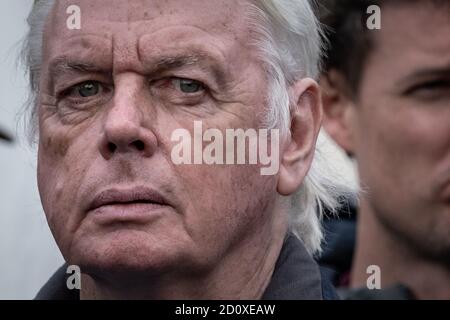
[22,0,353,254]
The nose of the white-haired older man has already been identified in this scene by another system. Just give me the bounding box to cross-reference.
[99,78,157,160]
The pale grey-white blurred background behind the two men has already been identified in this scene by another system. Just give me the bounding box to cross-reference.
[0,0,356,300]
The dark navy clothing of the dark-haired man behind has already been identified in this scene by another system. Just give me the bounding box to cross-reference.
[318,203,414,300]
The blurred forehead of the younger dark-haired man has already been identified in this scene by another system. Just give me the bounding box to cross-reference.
[369,1,450,78]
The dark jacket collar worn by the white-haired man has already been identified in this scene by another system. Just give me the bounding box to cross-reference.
[36,234,339,300]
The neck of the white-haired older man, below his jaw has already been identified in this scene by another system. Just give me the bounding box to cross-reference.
[80,210,286,300]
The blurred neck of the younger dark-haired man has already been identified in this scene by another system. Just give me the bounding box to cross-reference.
[351,199,450,299]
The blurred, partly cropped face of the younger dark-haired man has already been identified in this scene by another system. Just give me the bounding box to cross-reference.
[326,1,450,261]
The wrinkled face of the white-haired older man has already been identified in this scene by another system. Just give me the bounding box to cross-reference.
[38,0,284,280]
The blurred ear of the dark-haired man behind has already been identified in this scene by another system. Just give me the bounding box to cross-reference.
[320,70,355,155]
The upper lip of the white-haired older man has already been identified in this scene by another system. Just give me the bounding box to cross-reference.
[88,187,170,212]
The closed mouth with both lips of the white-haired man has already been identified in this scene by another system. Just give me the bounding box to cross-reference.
[88,187,170,222]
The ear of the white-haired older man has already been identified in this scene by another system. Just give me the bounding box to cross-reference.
[277,78,323,196]
